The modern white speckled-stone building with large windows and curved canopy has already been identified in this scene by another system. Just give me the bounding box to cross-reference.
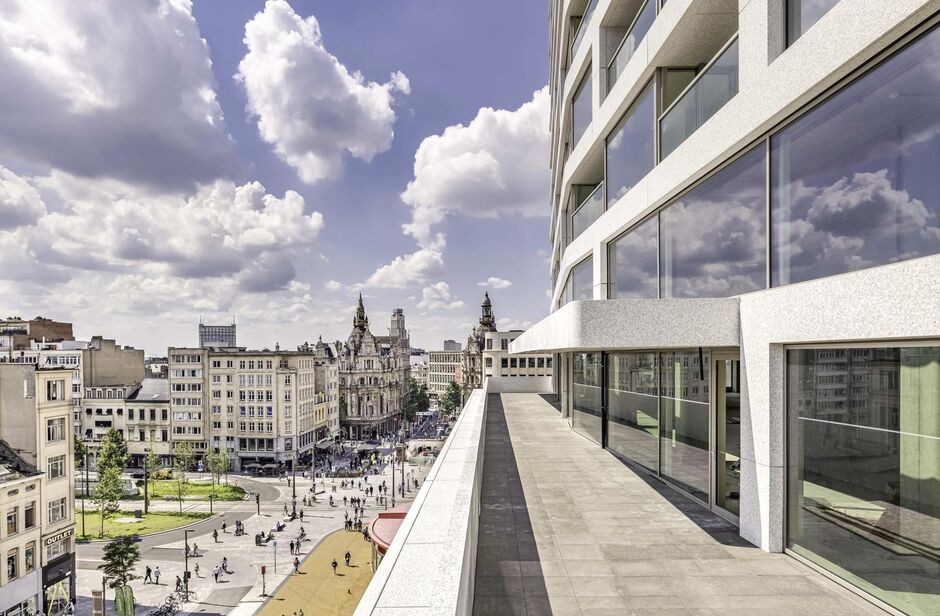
[510,0,940,614]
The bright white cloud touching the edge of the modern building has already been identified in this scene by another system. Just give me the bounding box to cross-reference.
[401,86,550,242]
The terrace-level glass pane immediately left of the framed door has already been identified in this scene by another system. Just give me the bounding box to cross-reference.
[660,350,709,501]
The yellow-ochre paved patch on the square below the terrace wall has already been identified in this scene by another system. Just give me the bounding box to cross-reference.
[258,530,372,616]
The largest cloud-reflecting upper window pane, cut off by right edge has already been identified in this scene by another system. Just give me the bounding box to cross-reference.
[770,31,940,285]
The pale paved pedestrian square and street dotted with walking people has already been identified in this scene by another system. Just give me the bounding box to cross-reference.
[76,463,431,616]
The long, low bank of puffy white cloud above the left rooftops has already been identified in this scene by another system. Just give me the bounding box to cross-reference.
[0,167,323,292]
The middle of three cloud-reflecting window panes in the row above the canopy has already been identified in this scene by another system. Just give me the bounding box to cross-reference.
[660,145,767,297]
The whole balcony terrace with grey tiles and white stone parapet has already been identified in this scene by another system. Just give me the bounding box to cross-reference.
[356,379,883,616]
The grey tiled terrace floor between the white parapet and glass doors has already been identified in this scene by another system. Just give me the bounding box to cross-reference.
[473,394,884,616]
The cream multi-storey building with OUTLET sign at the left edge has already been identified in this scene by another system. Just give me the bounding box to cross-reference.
[0,364,75,614]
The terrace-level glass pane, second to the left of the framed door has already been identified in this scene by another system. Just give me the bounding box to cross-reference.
[607,352,659,471]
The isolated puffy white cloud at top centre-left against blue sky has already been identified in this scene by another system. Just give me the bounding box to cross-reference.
[236,0,410,184]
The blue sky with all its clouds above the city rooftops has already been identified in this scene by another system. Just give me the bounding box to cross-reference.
[0,0,550,355]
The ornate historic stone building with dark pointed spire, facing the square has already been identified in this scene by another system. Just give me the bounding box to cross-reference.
[317,295,411,440]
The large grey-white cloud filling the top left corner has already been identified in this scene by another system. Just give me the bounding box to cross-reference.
[0,0,237,189]
